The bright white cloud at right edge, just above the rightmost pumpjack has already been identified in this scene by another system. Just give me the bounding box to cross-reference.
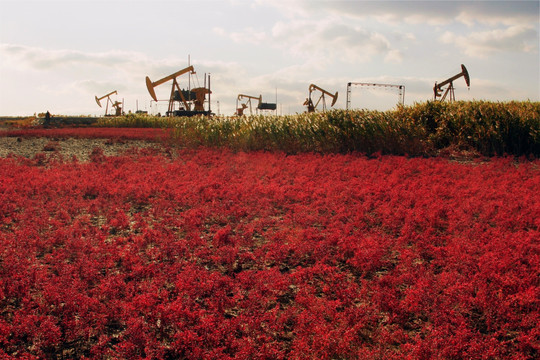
[440,26,538,57]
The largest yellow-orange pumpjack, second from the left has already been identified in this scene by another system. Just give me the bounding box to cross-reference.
[146,66,212,116]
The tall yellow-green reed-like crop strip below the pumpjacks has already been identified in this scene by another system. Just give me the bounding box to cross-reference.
[98,101,540,157]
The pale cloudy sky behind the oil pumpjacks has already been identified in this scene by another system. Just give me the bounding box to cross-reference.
[0,0,540,116]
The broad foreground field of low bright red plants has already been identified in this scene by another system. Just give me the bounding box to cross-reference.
[0,148,540,359]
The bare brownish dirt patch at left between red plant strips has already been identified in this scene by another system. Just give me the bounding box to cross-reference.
[0,136,163,161]
